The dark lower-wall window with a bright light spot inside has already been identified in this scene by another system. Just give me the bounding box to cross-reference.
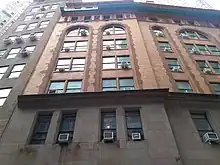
[101,111,116,139]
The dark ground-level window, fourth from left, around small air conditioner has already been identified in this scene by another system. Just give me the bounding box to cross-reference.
[125,108,144,140]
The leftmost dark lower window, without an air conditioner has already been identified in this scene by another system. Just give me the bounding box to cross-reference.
[30,112,52,144]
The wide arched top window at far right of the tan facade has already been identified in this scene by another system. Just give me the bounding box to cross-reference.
[179,30,208,40]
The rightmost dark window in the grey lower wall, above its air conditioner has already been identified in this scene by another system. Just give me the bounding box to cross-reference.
[191,113,214,138]
